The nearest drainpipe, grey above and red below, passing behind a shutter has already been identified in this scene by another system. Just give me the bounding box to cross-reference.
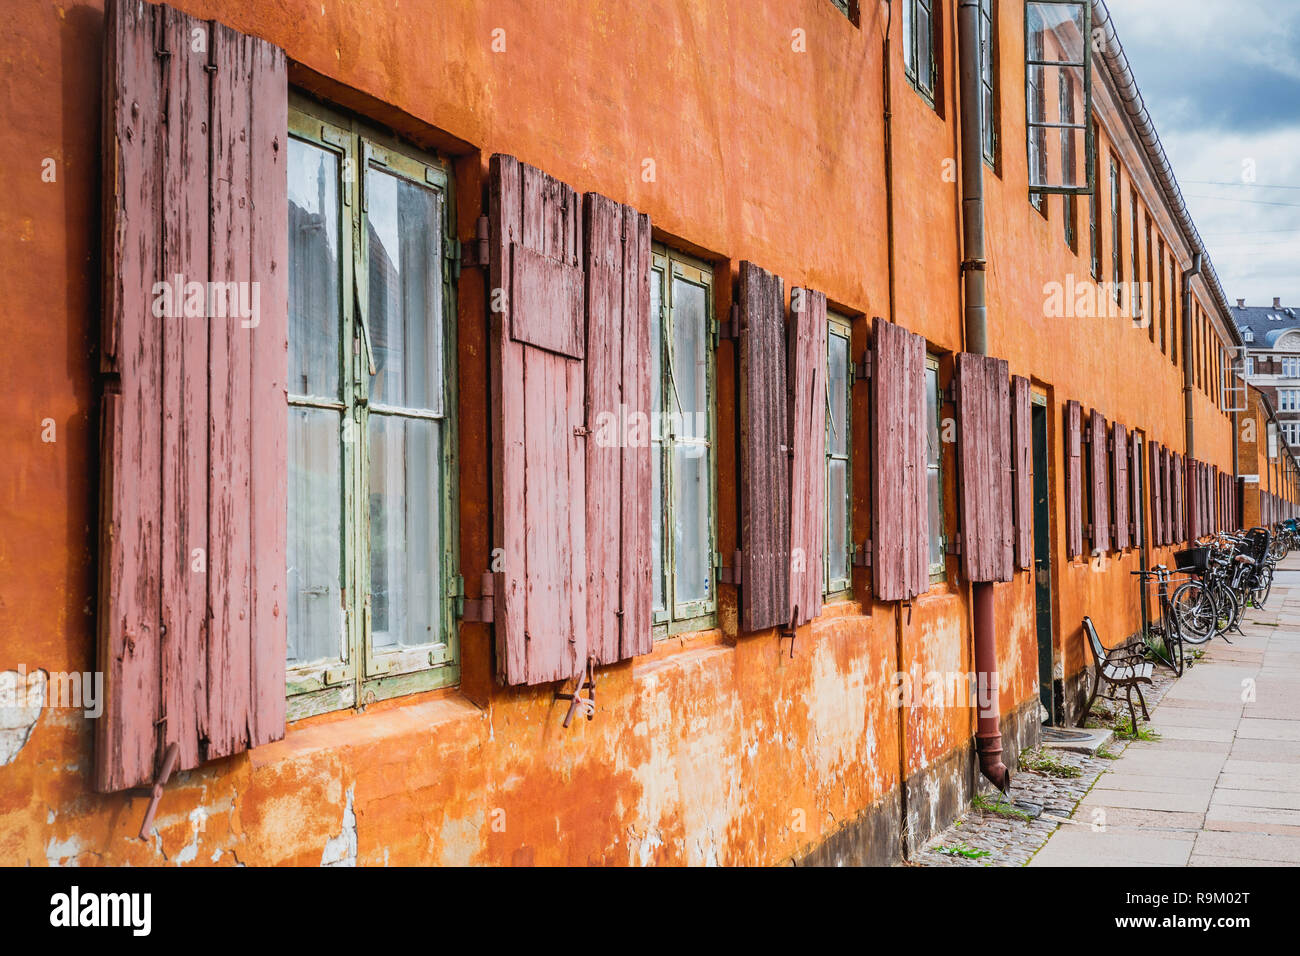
[957,0,1011,793]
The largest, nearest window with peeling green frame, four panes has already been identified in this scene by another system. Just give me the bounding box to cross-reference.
[286,96,459,719]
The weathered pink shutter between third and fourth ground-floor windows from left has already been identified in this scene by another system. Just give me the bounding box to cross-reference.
[871,320,930,601]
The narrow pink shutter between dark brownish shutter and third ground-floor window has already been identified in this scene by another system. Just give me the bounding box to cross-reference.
[787,289,826,624]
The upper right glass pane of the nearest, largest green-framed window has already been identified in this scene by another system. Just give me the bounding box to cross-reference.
[365,168,442,412]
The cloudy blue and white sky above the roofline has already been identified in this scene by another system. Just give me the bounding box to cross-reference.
[1106,0,1300,306]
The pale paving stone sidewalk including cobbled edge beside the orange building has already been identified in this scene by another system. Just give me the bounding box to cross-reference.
[911,555,1300,866]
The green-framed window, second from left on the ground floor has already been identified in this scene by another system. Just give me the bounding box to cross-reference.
[650,245,718,637]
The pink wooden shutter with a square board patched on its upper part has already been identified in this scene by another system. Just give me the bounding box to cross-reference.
[489,153,587,684]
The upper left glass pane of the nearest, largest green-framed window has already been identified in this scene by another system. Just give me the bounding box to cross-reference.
[289,138,341,398]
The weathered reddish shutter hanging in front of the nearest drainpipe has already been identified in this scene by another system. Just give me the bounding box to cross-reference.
[957,352,1013,581]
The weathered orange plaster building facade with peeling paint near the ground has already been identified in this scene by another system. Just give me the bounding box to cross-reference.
[0,0,1295,865]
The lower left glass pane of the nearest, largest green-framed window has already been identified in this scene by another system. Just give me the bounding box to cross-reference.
[286,407,346,666]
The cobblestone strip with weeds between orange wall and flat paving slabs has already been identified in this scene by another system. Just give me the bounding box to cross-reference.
[910,613,1201,866]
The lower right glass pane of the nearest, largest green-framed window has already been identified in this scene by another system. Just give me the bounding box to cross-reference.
[369,414,443,649]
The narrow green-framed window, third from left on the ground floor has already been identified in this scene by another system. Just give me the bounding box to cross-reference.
[822,312,853,594]
